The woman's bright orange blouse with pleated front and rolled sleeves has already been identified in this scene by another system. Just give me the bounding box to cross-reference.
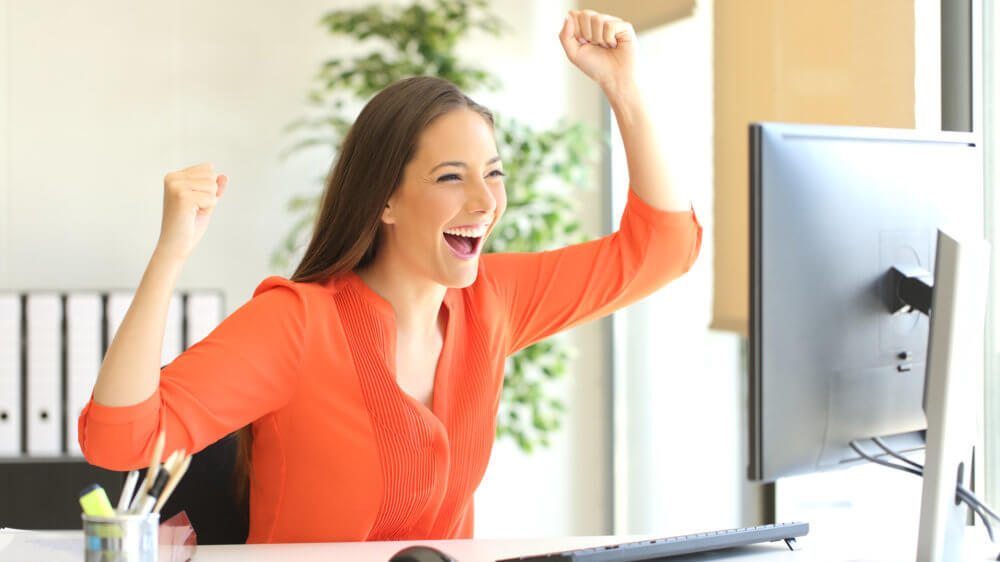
[78,189,702,543]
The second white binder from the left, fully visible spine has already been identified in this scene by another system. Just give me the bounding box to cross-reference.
[25,293,63,456]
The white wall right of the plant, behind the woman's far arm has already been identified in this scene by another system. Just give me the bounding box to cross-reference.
[462,0,611,537]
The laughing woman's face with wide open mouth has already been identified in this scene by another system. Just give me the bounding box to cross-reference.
[379,109,507,288]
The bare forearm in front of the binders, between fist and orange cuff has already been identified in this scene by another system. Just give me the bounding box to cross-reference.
[94,247,184,406]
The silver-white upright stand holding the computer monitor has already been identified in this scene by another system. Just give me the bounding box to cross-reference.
[917,230,990,562]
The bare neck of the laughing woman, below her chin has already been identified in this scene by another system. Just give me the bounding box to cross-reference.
[355,259,448,339]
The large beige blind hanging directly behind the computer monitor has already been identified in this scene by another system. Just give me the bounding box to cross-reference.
[711,0,914,334]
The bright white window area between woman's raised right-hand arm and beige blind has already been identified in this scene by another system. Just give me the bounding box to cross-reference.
[612,0,750,536]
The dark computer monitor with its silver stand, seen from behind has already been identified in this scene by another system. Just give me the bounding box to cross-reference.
[748,123,989,562]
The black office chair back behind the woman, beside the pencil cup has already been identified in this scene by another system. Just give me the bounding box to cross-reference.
[139,433,250,544]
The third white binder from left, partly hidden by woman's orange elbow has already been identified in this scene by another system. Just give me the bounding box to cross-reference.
[66,293,104,456]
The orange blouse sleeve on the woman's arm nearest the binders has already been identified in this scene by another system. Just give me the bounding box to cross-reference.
[77,277,308,470]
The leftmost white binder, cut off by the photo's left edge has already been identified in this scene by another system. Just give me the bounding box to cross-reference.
[0,293,22,457]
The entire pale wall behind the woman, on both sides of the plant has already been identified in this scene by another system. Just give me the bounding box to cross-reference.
[0,0,610,536]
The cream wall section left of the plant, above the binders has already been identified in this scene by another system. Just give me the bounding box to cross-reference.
[0,0,329,298]
